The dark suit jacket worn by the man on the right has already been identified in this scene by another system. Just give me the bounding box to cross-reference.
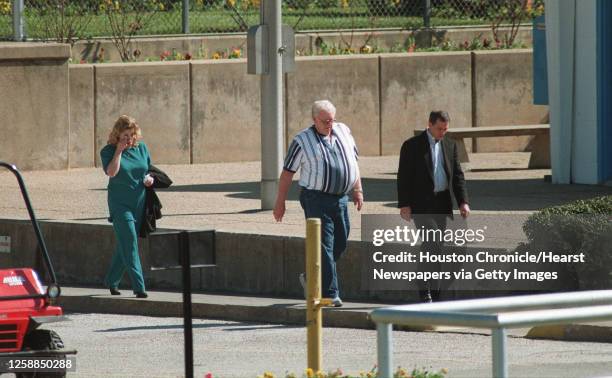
[397,131,468,215]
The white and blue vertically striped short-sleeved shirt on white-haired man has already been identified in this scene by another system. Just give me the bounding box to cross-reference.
[283,122,359,194]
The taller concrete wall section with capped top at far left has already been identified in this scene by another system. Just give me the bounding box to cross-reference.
[0,42,70,169]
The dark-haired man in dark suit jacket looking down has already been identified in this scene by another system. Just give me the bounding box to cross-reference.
[397,110,470,302]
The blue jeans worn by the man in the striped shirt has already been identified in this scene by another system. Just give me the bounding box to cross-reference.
[300,188,351,298]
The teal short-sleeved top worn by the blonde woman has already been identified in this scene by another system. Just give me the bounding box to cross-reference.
[100,142,151,223]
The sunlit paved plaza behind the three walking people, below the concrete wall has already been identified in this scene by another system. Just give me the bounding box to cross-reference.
[0,153,612,240]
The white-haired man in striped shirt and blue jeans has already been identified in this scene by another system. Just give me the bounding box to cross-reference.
[273,100,363,307]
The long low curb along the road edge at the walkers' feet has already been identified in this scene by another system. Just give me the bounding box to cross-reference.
[57,295,612,343]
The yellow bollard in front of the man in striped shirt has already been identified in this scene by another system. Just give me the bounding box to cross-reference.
[306,218,331,373]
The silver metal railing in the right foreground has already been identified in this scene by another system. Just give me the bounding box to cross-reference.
[370,290,612,378]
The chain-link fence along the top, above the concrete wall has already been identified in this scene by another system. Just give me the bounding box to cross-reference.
[0,0,535,42]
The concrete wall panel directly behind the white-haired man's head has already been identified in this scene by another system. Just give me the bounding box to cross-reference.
[286,56,380,156]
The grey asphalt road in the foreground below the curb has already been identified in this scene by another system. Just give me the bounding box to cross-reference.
[34,314,612,378]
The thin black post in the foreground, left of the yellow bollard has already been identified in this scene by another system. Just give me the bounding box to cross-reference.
[179,231,193,378]
